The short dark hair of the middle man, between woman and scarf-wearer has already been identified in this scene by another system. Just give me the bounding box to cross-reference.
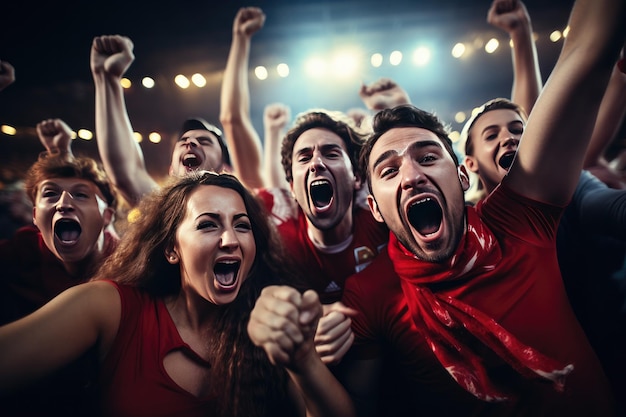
[280,109,365,182]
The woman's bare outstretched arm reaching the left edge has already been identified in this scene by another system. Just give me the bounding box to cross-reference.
[0,281,121,397]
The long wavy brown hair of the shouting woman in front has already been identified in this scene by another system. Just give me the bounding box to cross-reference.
[93,171,304,416]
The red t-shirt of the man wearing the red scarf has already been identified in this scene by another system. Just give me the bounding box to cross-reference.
[343,185,612,417]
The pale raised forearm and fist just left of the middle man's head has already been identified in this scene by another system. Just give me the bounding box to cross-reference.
[263,103,291,188]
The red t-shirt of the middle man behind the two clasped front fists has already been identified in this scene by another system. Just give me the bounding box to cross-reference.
[258,189,389,303]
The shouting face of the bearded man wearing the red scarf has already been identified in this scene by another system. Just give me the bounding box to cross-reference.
[368,127,469,262]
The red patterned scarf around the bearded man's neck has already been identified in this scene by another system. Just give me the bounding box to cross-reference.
[389,209,574,401]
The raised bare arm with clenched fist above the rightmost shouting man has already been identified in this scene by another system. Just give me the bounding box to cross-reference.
[487,0,542,113]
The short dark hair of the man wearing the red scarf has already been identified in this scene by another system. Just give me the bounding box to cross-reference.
[359,104,459,190]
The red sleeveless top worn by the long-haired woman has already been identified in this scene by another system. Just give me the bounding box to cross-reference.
[100,282,215,417]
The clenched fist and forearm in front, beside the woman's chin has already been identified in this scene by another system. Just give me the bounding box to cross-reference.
[248,286,354,417]
